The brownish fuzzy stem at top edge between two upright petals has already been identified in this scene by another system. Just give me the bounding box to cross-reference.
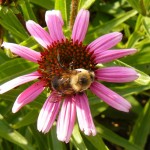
[69,0,79,30]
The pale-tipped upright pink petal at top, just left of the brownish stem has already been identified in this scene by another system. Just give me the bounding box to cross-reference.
[45,10,65,42]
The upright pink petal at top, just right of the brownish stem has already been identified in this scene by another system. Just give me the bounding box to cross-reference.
[71,9,90,43]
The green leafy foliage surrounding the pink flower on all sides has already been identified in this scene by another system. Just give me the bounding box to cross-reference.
[0,0,150,150]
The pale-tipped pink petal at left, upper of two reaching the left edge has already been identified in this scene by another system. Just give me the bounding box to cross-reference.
[2,42,41,63]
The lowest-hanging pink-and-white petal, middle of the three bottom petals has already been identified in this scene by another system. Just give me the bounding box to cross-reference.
[57,97,76,143]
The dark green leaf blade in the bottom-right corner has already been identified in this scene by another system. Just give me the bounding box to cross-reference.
[130,100,150,149]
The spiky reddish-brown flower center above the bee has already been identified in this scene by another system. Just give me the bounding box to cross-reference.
[38,39,95,90]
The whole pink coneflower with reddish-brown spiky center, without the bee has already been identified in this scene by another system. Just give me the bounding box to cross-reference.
[0,9,138,143]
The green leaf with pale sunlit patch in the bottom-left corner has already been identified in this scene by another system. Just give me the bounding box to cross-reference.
[0,115,34,150]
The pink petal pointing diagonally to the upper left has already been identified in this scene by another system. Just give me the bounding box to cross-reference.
[26,20,52,48]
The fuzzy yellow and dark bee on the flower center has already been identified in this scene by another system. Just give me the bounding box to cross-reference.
[51,69,95,96]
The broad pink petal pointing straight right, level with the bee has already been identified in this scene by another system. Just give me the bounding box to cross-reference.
[95,67,139,83]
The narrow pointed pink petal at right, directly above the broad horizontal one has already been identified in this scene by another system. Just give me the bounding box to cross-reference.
[94,49,137,63]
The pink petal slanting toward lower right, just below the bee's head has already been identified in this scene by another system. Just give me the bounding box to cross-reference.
[90,81,131,112]
